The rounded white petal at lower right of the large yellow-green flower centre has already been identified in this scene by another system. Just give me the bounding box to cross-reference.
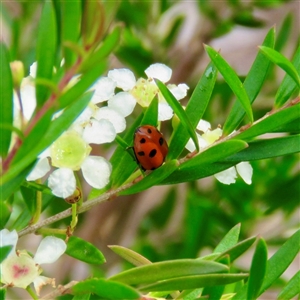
[81,156,111,189]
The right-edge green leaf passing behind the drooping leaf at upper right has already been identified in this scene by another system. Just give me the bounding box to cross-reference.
[275,47,300,108]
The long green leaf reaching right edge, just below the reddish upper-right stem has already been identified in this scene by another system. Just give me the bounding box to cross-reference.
[235,103,300,140]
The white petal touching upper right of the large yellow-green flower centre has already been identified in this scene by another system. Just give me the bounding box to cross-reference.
[82,119,116,144]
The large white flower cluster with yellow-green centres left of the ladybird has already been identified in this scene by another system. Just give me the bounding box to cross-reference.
[21,63,188,198]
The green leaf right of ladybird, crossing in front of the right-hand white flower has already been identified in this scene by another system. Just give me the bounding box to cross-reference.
[179,140,248,170]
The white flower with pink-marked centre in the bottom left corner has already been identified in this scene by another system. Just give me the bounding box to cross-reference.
[0,229,67,295]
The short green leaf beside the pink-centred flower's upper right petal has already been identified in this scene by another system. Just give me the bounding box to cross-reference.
[65,236,105,265]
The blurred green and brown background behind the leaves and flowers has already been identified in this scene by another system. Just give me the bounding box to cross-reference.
[0,0,300,299]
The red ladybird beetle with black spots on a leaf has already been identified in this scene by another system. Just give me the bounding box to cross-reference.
[133,125,169,170]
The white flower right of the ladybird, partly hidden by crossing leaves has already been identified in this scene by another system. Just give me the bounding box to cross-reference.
[185,120,253,184]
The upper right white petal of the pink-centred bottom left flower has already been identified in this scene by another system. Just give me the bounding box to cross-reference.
[33,236,67,265]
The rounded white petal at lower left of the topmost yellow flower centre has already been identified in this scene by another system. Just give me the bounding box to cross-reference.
[108,92,136,117]
